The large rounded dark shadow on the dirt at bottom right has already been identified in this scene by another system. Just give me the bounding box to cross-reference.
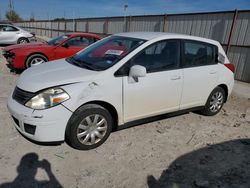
[147,139,250,188]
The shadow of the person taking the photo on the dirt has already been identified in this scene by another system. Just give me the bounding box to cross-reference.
[0,153,62,188]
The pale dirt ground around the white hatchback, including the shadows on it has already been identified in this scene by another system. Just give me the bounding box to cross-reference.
[0,47,250,188]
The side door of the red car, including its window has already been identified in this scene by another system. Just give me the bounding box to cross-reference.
[54,36,95,59]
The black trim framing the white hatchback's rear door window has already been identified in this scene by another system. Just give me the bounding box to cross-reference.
[180,39,219,69]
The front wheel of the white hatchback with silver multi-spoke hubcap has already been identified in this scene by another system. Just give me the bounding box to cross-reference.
[66,104,113,150]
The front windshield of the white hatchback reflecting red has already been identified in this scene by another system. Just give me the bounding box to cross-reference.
[66,36,145,71]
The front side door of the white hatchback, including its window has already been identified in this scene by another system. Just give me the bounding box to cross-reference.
[118,40,183,122]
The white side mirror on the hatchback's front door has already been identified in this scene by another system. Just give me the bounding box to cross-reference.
[128,65,147,83]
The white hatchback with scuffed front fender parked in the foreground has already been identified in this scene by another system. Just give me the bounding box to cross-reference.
[8,32,234,150]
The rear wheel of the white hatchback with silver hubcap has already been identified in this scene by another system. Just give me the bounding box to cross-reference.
[201,87,226,116]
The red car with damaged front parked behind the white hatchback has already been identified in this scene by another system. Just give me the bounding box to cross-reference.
[3,33,101,70]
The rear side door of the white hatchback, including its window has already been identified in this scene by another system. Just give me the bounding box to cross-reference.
[180,40,218,109]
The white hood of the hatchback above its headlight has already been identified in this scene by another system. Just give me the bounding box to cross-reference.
[17,59,98,92]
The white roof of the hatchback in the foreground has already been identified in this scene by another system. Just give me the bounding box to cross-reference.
[115,32,218,45]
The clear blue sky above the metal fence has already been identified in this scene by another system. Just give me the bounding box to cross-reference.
[0,0,250,20]
